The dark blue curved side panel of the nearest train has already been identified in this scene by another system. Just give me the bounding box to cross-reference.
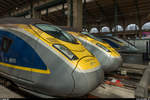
[0,30,47,70]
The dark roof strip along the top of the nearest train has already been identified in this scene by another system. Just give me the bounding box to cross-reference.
[0,17,50,24]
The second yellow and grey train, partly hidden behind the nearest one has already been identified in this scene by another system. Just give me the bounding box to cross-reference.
[60,26,123,73]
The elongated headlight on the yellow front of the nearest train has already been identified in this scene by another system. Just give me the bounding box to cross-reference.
[53,44,78,60]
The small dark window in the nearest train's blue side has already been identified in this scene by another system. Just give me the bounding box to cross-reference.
[1,37,12,52]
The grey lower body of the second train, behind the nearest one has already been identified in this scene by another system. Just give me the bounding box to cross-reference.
[76,37,122,72]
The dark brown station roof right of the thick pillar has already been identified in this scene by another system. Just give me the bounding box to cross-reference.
[86,0,150,23]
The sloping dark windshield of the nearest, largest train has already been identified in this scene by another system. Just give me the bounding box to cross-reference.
[35,24,77,43]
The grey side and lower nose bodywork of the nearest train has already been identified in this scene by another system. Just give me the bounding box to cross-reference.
[0,29,104,97]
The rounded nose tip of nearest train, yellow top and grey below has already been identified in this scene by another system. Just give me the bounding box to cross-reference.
[71,57,104,96]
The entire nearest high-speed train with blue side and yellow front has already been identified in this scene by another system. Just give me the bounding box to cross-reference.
[0,17,104,97]
